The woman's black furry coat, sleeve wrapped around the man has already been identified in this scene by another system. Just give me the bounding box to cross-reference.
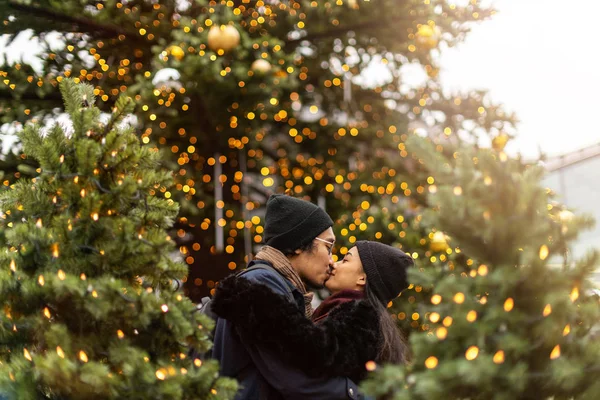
[211,275,381,383]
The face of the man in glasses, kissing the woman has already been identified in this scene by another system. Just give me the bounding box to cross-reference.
[290,228,335,287]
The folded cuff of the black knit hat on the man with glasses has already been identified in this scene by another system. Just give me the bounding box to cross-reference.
[265,207,333,250]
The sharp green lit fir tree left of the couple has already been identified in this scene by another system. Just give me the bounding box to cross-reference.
[0,79,236,399]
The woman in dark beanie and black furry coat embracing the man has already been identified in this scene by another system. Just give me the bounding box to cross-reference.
[212,241,413,382]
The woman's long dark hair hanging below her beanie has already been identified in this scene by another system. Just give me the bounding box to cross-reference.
[365,281,410,364]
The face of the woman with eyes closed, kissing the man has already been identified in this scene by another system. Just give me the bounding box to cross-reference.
[325,246,367,294]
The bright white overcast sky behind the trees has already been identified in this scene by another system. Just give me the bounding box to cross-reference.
[0,0,600,158]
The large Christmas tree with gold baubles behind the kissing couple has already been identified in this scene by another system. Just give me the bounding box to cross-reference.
[0,0,514,300]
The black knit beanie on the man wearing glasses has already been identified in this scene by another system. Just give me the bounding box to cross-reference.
[264,194,333,250]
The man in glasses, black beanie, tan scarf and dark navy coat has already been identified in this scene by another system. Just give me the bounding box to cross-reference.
[213,195,361,400]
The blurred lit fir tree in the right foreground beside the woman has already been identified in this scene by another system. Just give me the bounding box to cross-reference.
[364,137,600,399]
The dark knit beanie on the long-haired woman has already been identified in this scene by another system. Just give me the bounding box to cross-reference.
[356,240,414,304]
